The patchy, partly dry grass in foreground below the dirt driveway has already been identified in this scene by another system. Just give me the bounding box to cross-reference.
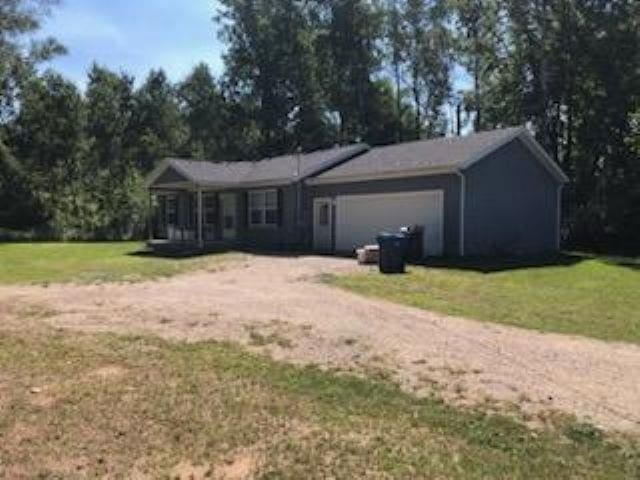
[0,323,640,479]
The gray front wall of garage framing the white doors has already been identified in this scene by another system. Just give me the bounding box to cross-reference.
[303,175,460,256]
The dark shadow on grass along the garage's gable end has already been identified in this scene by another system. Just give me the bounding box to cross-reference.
[415,253,589,273]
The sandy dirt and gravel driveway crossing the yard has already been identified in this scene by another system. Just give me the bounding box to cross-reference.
[0,256,640,433]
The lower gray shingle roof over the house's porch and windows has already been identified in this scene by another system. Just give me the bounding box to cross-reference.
[154,144,369,185]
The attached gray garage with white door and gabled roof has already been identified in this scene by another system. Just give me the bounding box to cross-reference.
[305,128,567,256]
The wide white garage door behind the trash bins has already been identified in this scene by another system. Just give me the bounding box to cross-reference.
[336,190,443,255]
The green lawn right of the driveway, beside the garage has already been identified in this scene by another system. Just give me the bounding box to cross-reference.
[328,255,640,343]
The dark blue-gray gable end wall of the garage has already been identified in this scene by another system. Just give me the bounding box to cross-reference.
[465,140,559,255]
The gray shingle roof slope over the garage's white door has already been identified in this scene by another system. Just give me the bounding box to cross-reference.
[316,127,523,180]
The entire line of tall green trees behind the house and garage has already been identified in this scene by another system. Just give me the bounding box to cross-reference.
[0,0,640,247]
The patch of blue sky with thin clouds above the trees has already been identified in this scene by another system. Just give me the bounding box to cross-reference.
[42,0,223,86]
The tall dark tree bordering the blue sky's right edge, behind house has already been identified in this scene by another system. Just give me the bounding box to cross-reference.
[218,0,329,155]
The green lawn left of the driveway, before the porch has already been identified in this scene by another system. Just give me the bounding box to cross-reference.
[0,242,239,284]
